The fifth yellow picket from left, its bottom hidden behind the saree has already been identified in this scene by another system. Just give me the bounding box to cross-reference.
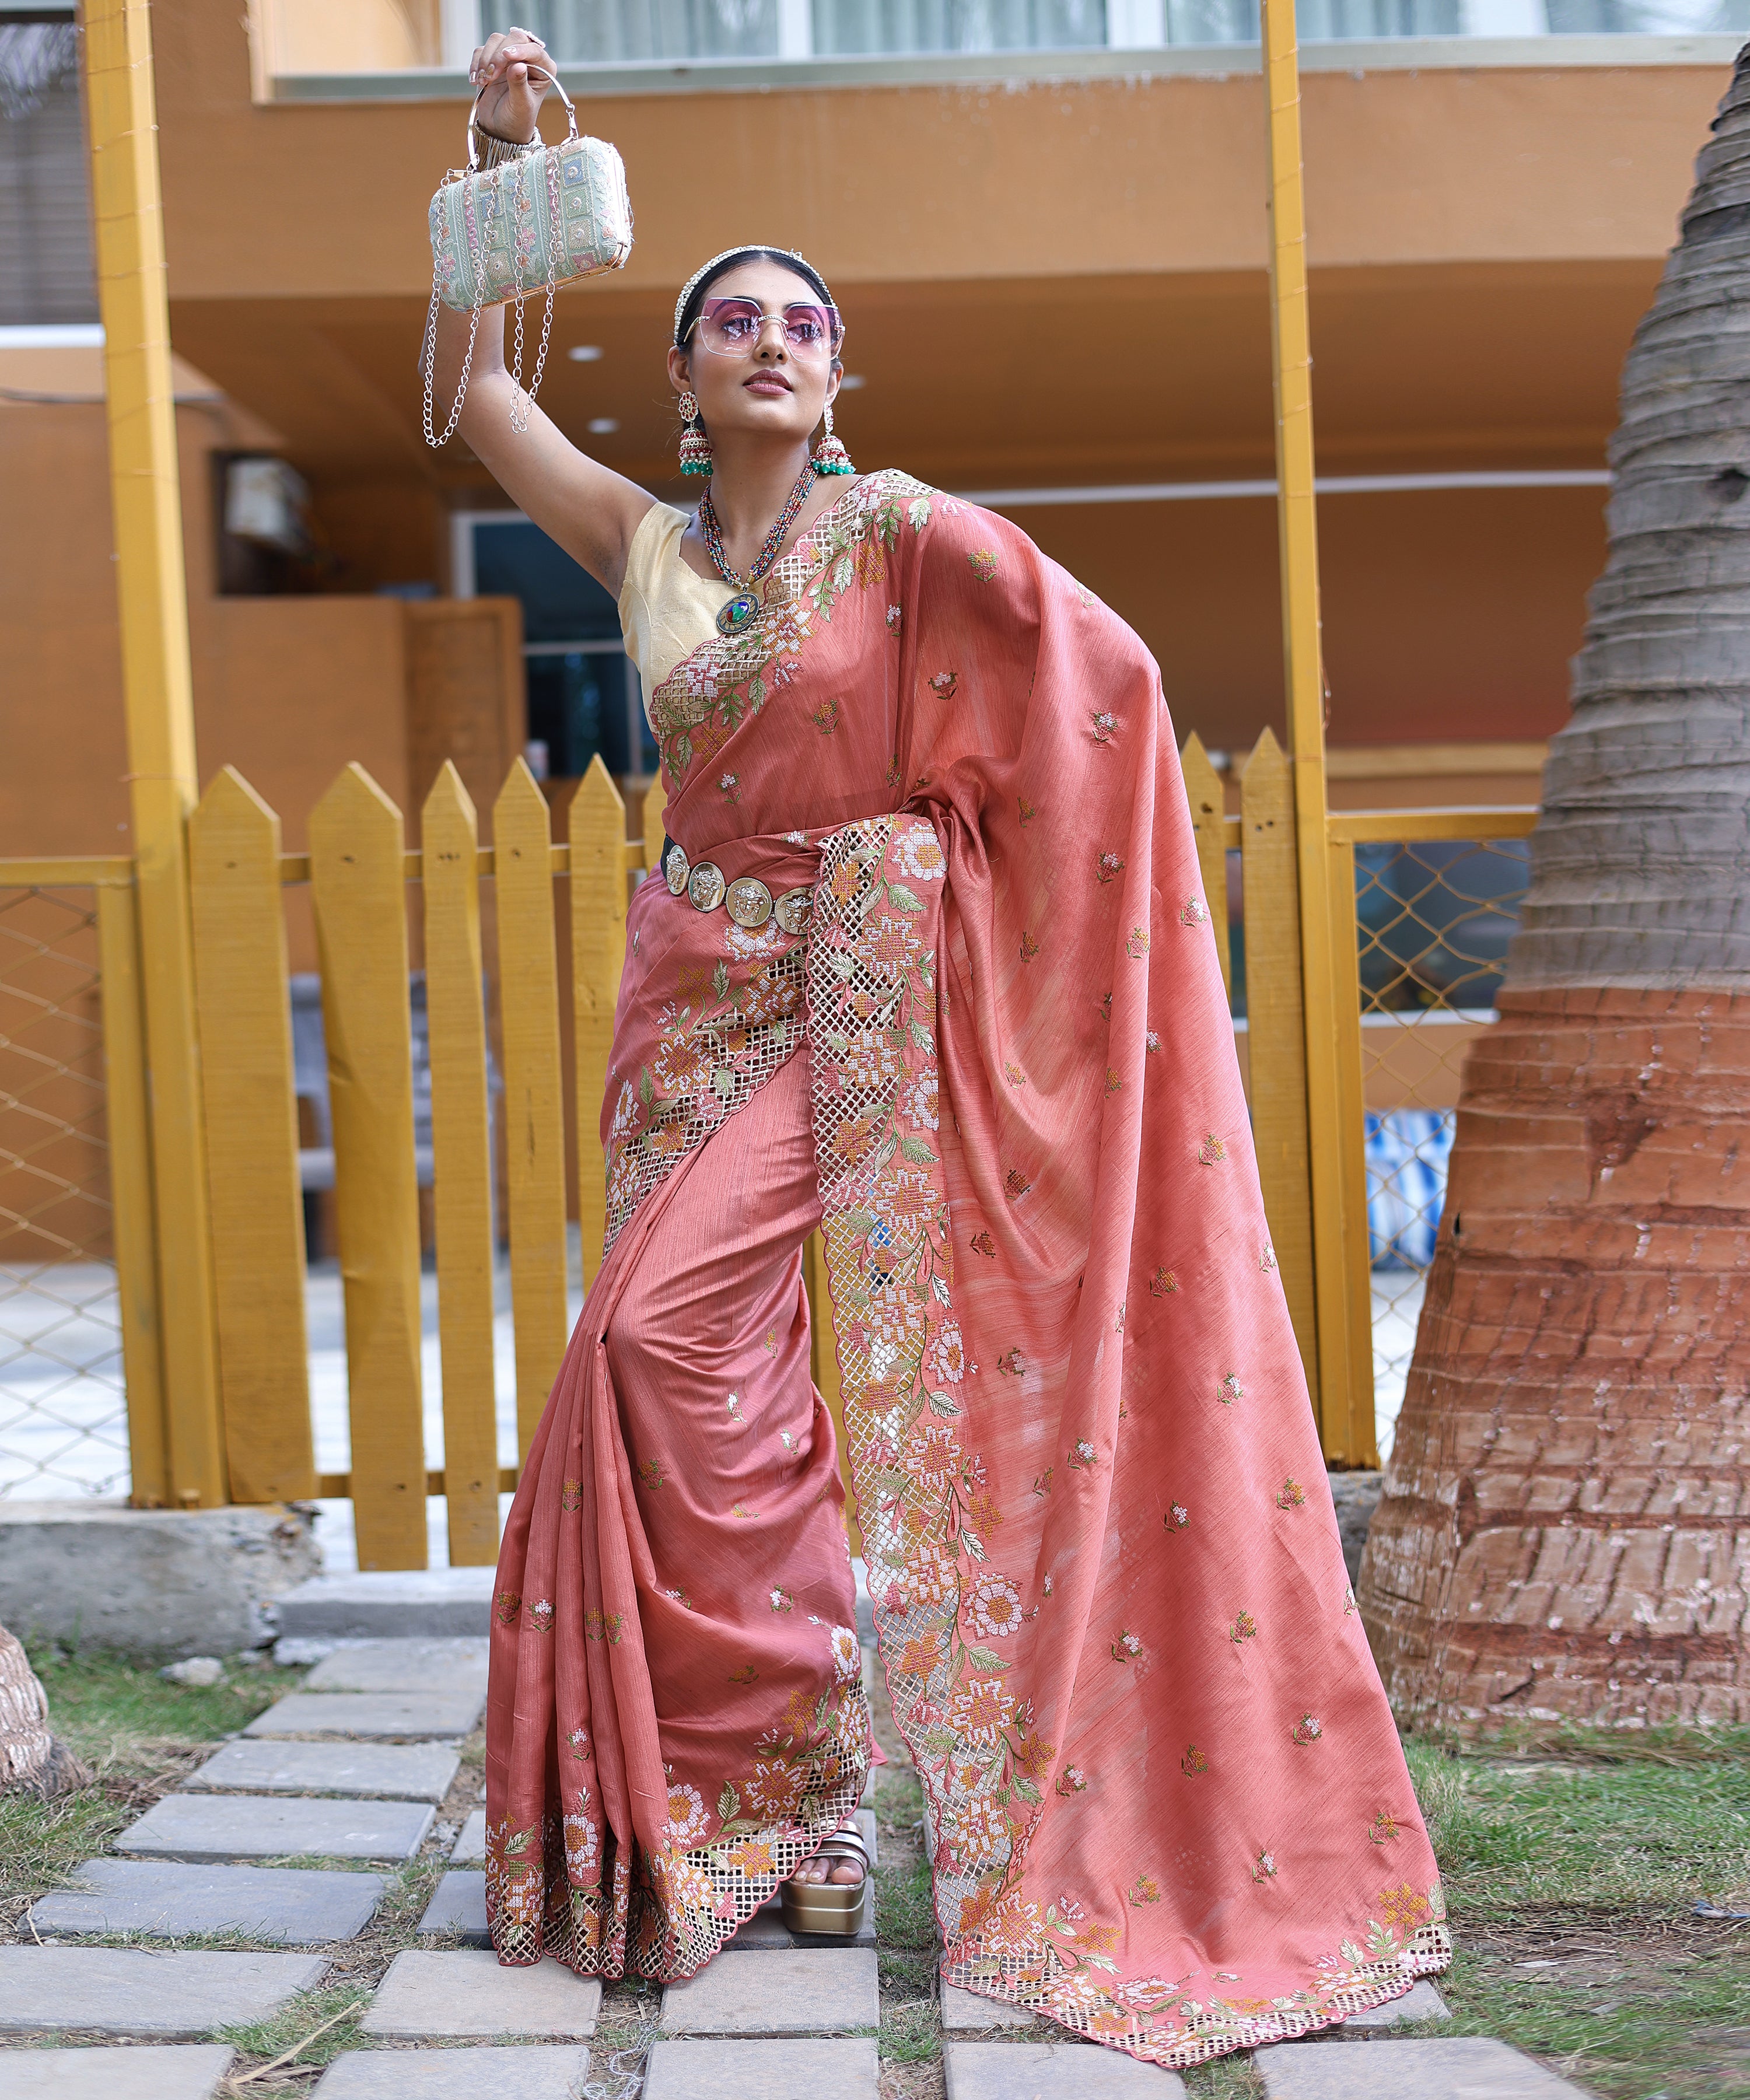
[572,754,626,1285]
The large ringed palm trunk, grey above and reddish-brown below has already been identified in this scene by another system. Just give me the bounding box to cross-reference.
[1359,46,1750,1732]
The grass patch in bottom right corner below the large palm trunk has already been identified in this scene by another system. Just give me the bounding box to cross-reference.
[1403,1728,1750,2100]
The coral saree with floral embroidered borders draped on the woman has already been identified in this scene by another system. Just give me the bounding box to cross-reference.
[488,475,1447,2064]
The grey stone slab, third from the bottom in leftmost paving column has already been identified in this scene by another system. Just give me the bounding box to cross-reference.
[29,1859,382,1947]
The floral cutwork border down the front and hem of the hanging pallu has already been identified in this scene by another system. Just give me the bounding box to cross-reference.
[809,817,1452,2068]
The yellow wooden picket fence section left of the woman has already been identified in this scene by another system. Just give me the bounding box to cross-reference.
[175,760,657,1567]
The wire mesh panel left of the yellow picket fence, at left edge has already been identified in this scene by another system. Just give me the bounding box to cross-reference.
[0,886,128,1499]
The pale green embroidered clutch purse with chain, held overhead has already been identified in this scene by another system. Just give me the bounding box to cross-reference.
[420,67,632,445]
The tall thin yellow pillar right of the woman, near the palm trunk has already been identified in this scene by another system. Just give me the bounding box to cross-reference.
[1262,0,1353,1457]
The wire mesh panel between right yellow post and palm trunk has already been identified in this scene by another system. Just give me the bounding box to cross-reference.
[1355,838,1527,1455]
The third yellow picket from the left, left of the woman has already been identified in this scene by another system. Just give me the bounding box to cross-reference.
[420,758,498,1567]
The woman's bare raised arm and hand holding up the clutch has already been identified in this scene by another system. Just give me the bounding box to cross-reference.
[430,29,653,598]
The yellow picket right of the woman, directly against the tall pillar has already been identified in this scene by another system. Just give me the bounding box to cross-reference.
[1240,729,1320,1392]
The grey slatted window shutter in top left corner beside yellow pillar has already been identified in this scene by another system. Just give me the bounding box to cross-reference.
[0,8,97,328]
